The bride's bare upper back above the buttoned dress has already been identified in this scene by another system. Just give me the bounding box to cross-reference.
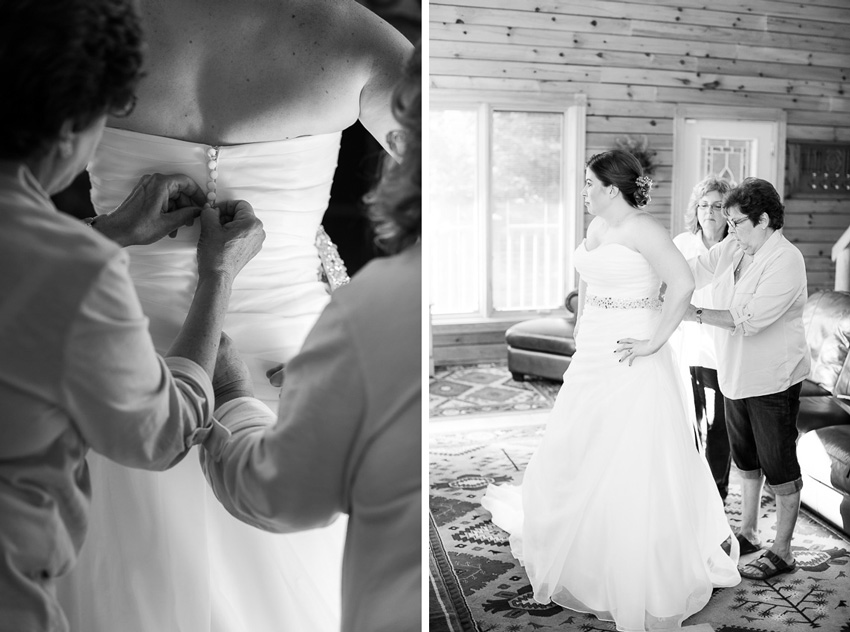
[110,0,412,145]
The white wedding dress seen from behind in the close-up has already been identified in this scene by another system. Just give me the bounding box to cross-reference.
[59,129,346,632]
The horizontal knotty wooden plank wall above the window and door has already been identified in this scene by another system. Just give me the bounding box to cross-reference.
[430,0,850,291]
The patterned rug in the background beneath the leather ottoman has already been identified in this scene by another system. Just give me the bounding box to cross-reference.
[430,363,561,418]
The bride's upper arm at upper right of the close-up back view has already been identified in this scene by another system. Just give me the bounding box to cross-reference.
[352,10,413,159]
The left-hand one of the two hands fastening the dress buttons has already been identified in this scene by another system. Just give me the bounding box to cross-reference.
[92,173,206,246]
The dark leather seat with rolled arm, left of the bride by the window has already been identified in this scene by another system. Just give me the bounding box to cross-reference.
[505,291,578,382]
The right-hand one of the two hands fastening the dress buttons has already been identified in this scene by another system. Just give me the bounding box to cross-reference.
[198,200,266,280]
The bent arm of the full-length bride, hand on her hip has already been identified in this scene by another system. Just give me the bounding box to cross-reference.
[632,213,694,353]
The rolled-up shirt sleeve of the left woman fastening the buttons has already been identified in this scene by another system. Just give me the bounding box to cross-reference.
[61,252,214,470]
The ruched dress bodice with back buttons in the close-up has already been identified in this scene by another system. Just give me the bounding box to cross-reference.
[89,128,340,402]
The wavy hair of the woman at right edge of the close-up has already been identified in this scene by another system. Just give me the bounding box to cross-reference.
[364,41,422,254]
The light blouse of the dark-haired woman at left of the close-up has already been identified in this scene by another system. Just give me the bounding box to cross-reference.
[0,162,213,632]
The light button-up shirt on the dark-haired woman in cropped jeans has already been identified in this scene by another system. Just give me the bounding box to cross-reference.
[689,231,811,399]
